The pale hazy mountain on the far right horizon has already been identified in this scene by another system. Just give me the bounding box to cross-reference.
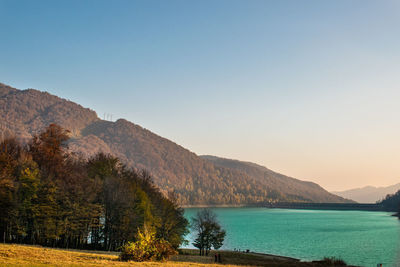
[332,183,400,203]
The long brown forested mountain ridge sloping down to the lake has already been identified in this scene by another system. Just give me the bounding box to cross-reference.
[0,84,347,205]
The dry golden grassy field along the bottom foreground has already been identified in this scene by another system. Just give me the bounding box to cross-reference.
[0,244,350,267]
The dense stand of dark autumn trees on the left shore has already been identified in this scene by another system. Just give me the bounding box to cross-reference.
[0,124,188,250]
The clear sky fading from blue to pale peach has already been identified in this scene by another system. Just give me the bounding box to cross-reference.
[0,0,400,193]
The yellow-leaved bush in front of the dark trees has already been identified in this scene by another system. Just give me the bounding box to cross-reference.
[119,227,178,261]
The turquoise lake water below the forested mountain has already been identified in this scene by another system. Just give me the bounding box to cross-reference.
[185,208,400,267]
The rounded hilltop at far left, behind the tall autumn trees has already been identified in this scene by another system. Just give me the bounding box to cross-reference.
[0,83,99,142]
